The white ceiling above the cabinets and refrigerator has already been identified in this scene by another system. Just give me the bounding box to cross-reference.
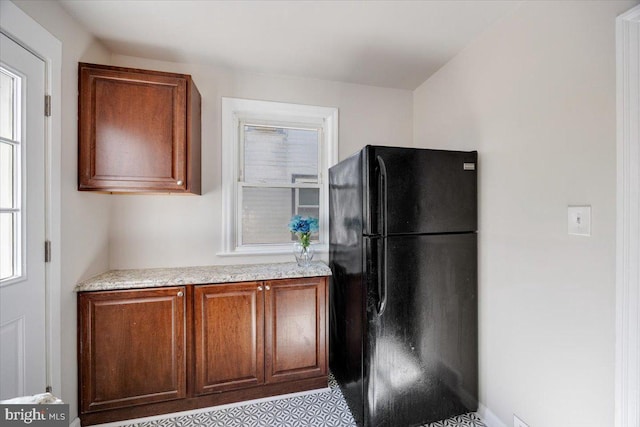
[60,0,520,90]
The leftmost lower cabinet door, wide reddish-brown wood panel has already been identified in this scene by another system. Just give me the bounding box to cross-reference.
[79,287,186,413]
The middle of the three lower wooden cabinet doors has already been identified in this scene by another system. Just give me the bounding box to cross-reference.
[194,282,264,394]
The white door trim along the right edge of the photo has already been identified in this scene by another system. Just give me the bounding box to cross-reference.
[615,6,640,427]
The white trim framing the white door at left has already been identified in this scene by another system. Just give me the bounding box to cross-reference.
[0,1,62,402]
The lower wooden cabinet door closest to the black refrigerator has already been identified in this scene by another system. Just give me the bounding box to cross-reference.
[265,278,327,383]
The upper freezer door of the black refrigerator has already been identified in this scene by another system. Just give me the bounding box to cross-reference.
[365,146,478,235]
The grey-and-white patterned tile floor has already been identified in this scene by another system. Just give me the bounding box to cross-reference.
[104,376,485,427]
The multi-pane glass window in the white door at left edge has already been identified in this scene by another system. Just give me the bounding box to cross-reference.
[0,67,23,282]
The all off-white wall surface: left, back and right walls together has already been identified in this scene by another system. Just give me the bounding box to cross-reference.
[15,0,635,427]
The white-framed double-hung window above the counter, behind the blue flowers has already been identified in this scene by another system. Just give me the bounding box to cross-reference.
[221,98,338,255]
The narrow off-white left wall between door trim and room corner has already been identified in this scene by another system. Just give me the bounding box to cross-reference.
[14,0,110,418]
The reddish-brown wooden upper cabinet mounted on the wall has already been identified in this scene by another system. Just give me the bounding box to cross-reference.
[78,63,201,194]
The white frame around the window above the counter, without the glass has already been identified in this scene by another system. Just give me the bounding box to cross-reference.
[218,97,338,256]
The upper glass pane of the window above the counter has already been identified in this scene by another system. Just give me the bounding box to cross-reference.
[243,125,318,183]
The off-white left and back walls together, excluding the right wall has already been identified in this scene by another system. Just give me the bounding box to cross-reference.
[7,0,413,418]
